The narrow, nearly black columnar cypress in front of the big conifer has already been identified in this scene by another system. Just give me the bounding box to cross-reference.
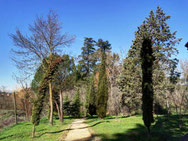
[141,38,154,134]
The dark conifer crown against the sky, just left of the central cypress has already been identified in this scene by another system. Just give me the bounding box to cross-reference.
[79,37,97,78]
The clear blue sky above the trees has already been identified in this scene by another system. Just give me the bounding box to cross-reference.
[0,0,188,89]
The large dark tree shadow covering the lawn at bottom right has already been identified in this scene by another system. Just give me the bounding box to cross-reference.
[90,115,188,141]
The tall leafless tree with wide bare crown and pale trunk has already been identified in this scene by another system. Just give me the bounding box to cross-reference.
[10,11,75,125]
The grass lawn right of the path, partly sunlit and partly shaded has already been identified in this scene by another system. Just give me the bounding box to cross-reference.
[86,116,188,141]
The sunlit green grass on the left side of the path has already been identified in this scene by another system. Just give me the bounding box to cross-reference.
[0,118,73,141]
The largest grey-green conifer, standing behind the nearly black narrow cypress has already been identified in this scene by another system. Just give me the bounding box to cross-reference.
[119,7,181,114]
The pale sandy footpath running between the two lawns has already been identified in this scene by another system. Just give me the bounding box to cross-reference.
[65,119,91,141]
